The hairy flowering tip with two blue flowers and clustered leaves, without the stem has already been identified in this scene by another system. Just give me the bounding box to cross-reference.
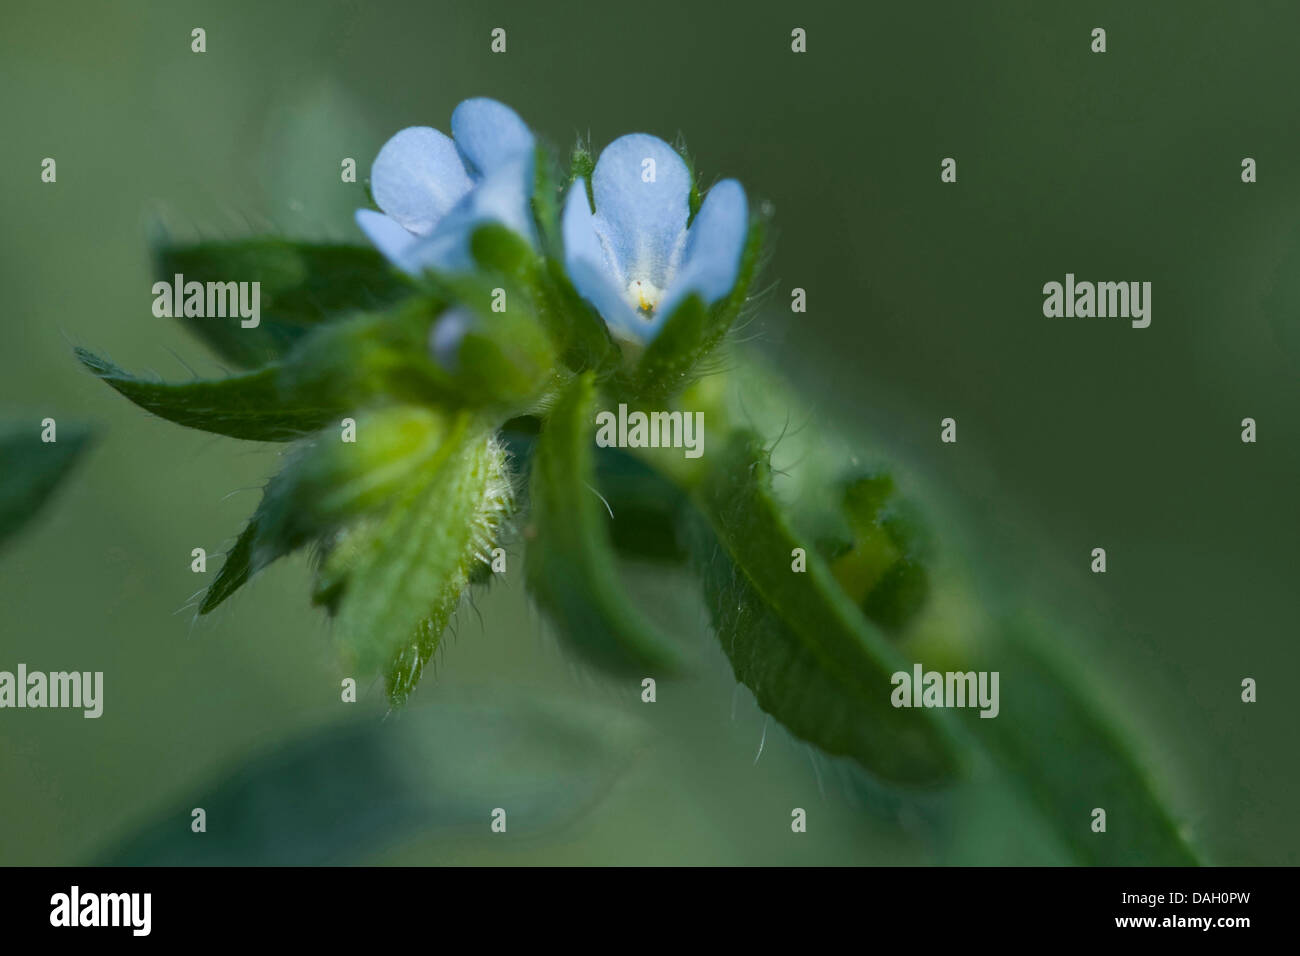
[79,99,761,704]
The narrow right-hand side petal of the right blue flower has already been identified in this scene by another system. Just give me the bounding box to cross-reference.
[655,179,749,325]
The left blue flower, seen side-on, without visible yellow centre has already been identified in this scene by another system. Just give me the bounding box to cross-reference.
[356,98,536,276]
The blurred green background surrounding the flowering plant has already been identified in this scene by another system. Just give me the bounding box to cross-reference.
[0,0,1300,864]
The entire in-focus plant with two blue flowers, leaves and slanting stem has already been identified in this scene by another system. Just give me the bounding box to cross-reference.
[68,99,1196,865]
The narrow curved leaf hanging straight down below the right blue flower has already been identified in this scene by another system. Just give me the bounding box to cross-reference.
[527,372,680,675]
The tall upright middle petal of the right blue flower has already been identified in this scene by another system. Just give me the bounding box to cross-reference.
[592,133,690,289]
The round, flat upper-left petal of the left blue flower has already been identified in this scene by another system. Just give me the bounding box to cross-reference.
[371,126,472,235]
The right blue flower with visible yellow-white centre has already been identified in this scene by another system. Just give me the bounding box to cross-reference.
[562,133,749,342]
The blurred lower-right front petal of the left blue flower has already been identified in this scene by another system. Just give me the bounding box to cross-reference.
[403,152,537,272]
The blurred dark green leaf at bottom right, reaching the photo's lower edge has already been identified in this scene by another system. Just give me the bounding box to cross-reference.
[961,620,1201,866]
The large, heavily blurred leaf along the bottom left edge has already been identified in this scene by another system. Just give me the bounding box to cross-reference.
[96,688,645,866]
